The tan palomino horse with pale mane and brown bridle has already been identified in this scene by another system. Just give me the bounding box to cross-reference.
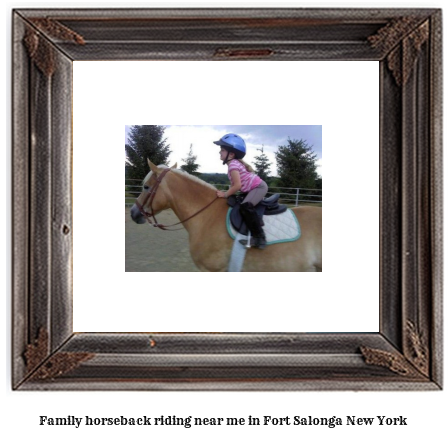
[131,160,322,272]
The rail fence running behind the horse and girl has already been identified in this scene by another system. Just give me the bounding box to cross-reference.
[125,179,322,207]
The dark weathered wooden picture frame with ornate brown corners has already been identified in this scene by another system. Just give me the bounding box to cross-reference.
[12,9,442,390]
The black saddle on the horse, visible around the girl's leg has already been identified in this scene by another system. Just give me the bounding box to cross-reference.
[227,193,287,236]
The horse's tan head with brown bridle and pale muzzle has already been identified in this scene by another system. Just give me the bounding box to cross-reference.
[131,159,177,224]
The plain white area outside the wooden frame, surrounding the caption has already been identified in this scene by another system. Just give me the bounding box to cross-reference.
[0,1,448,438]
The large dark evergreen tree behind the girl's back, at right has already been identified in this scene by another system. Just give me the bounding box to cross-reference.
[275,138,318,189]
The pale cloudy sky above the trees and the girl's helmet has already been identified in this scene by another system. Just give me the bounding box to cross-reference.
[125,125,322,176]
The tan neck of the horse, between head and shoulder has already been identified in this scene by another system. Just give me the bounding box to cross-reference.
[169,173,216,230]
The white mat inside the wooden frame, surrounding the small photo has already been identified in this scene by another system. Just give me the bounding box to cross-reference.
[73,61,379,332]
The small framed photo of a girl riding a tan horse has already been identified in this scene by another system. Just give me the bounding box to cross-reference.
[125,125,322,272]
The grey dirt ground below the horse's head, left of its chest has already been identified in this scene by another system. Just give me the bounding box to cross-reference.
[125,207,199,272]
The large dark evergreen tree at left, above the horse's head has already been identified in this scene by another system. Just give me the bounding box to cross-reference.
[125,125,171,180]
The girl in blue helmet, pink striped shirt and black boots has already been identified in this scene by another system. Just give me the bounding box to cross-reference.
[213,134,268,249]
